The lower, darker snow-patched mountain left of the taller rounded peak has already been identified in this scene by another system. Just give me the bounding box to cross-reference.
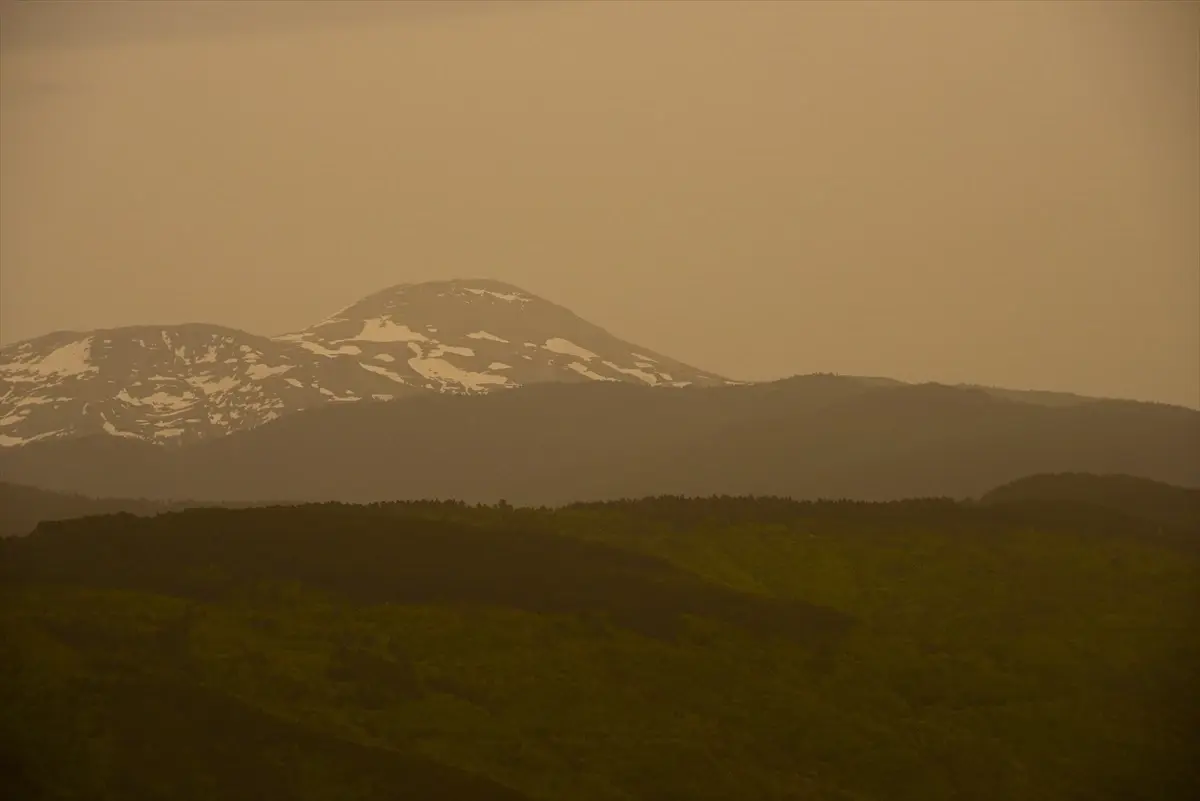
[0,324,432,446]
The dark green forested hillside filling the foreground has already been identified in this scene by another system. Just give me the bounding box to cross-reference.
[0,489,1200,801]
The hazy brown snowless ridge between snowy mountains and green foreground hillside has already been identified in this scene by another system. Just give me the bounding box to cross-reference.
[0,375,1200,505]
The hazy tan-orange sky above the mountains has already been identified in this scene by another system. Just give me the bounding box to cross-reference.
[0,0,1200,406]
